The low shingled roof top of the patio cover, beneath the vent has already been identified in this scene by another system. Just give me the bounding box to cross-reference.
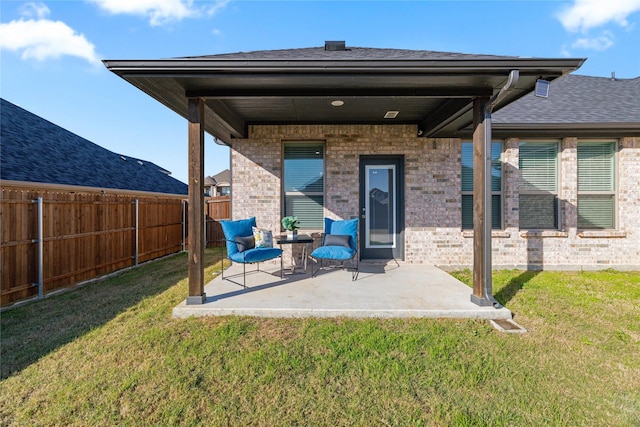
[185,46,516,61]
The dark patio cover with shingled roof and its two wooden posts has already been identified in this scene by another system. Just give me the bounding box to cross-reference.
[104,42,584,303]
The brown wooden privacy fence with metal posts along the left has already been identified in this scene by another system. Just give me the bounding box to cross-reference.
[0,185,229,305]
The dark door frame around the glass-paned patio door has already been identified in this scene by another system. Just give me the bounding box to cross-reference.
[358,154,405,260]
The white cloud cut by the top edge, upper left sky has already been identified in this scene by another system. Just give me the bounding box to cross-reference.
[88,0,228,27]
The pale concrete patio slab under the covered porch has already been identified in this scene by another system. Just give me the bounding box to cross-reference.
[173,263,512,319]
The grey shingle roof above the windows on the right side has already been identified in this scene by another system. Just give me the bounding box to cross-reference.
[493,75,640,126]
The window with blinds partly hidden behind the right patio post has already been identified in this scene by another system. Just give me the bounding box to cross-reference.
[461,142,502,230]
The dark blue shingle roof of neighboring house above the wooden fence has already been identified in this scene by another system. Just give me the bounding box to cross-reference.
[0,98,188,194]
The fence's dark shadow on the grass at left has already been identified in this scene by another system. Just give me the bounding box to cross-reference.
[0,248,222,379]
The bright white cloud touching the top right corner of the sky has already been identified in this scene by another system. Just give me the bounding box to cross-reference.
[558,0,640,32]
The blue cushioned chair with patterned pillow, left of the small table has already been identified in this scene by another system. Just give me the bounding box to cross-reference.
[220,217,282,288]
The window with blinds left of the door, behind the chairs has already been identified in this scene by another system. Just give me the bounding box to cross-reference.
[283,142,324,229]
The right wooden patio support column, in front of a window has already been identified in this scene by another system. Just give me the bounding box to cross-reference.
[471,97,494,306]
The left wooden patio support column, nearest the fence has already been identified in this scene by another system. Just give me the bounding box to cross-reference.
[186,98,206,305]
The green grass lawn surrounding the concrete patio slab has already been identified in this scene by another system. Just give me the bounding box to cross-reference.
[0,249,640,426]
